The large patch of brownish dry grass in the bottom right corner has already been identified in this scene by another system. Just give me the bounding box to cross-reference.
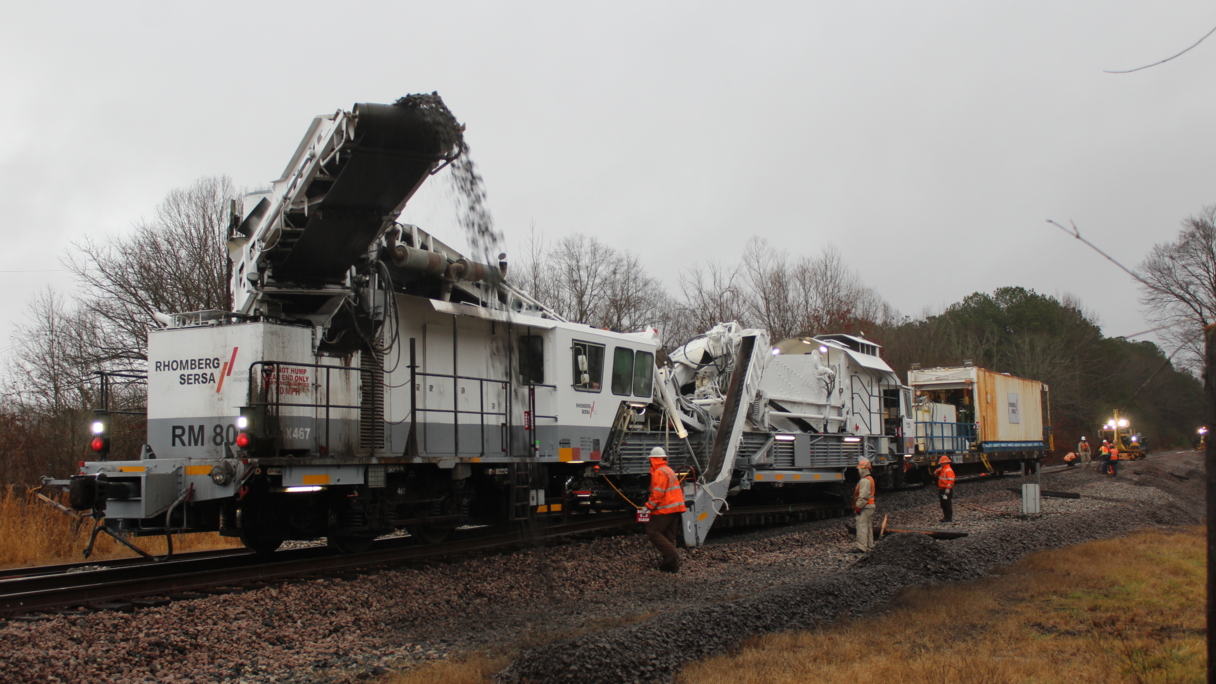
[679,528,1206,684]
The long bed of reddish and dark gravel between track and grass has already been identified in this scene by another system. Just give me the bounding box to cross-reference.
[0,453,1204,683]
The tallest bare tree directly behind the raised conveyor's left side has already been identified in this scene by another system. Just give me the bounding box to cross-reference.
[64,176,237,365]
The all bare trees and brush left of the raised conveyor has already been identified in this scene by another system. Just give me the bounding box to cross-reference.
[0,178,236,482]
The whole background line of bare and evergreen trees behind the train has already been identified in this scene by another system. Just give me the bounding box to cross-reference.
[0,176,1216,483]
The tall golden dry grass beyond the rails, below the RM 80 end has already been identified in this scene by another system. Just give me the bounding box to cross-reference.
[0,487,241,567]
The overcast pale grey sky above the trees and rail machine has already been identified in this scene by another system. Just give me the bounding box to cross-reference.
[0,0,1216,348]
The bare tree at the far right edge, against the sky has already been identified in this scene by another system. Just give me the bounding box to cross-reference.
[1137,204,1216,370]
